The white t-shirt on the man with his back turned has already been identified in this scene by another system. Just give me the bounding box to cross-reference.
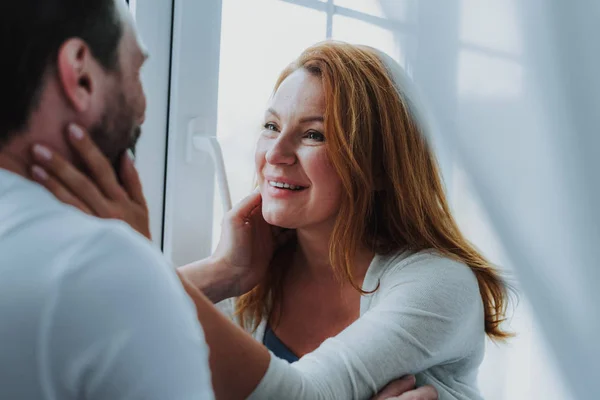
[0,170,214,400]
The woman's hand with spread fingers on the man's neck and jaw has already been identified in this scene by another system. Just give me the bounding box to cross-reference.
[31,124,150,239]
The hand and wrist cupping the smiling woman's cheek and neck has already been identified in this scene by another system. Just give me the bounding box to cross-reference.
[179,191,294,303]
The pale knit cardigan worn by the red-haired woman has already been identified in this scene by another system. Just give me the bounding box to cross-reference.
[220,251,485,400]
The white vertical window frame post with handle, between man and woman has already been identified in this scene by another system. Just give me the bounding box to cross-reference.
[161,0,222,266]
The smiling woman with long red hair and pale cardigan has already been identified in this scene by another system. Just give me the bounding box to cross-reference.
[30,42,509,399]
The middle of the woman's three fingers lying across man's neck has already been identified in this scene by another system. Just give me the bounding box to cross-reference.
[32,144,111,217]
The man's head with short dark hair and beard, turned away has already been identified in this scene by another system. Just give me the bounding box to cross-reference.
[0,0,146,170]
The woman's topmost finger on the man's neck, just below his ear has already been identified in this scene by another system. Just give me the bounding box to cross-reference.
[68,124,127,201]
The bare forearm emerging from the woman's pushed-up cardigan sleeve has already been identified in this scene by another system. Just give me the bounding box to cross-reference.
[178,271,271,399]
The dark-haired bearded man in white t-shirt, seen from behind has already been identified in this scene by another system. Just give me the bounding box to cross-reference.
[0,0,436,400]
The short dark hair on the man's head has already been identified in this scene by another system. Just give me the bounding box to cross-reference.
[0,0,123,146]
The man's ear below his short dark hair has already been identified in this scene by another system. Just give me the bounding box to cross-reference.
[56,39,96,112]
